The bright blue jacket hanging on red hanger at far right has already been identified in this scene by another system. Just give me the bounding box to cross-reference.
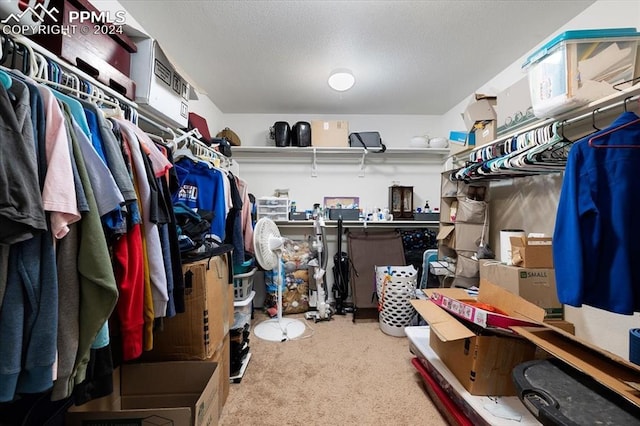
[553,112,640,314]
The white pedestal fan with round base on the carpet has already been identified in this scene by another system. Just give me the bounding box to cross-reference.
[253,217,305,342]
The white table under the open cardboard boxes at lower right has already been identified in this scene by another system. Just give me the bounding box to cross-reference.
[404,326,540,426]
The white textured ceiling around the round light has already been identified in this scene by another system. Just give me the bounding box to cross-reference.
[119,0,594,115]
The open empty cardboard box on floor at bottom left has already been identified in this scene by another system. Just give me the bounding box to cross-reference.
[65,361,219,426]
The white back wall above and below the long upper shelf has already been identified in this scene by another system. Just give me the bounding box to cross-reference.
[224,114,442,215]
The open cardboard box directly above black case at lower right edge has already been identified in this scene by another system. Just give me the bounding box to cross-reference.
[513,327,640,406]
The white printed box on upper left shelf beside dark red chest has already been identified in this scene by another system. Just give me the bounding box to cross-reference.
[131,39,190,127]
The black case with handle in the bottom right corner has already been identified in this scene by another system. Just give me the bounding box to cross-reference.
[512,358,640,426]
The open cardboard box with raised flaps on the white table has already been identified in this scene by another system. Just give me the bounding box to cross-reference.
[411,283,544,396]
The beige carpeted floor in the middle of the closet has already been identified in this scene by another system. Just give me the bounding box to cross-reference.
[220,312,446,426]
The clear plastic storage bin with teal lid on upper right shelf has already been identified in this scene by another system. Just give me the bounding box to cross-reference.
[522,28,640,118]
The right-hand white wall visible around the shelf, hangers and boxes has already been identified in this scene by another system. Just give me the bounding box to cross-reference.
[450,0,640,358]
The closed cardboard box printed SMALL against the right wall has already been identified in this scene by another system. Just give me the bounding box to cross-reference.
[480,261,564,319]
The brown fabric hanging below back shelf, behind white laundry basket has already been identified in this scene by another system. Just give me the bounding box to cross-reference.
[347,231,406,322]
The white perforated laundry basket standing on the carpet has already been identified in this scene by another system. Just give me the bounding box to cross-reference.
[375,265,418,337]
